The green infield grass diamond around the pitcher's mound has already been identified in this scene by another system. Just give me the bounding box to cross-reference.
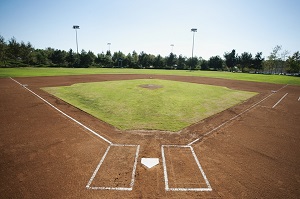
[43,79,256,131]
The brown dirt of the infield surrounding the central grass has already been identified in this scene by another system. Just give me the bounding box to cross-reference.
[0,75,300,198]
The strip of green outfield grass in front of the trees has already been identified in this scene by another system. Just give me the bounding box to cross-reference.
[0,68,300,85]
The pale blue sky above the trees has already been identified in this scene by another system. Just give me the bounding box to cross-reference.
[0,0,300,59]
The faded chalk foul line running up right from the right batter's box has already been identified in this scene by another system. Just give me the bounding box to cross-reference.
[187,84,288,146]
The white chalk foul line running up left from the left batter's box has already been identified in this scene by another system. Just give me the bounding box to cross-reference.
[10,77,112,144]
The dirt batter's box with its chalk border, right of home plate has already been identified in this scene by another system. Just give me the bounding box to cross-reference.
[161,145,212,191]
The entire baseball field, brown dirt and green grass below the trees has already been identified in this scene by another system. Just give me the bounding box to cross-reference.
[0,69,300,198]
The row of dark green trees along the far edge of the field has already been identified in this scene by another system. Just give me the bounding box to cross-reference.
[0,35,300,74]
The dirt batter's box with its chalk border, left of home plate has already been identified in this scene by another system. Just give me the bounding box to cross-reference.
[86,144,140,191]
